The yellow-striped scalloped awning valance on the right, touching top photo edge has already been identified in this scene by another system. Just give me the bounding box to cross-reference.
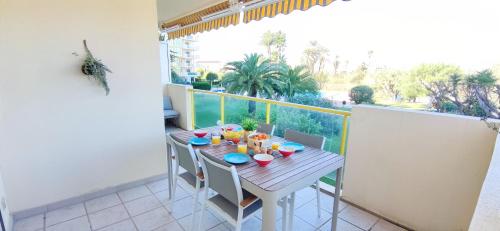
[243,0,334,23]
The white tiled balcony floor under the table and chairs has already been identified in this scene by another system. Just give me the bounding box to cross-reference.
[14,179,404,231]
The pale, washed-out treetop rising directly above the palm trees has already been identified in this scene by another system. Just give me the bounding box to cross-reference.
[260,31,286,62]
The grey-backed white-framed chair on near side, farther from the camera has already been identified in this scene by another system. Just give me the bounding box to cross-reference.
[167,134,205,230]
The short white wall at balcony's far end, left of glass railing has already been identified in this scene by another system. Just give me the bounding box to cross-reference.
[164,83,193,130]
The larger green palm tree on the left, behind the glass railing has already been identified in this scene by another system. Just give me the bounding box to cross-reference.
[222,53,282,114]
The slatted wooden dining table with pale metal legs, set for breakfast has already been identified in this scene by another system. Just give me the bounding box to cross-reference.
[167,131,344,231]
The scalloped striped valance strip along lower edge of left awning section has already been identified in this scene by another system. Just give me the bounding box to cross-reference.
[168,13,240,39]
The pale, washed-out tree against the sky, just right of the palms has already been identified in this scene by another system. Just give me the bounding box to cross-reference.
[303,41,330,74]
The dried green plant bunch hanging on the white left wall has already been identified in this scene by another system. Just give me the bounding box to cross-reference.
[82,40,113,95]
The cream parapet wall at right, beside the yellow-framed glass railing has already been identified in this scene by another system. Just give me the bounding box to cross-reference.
[343,106,496,231]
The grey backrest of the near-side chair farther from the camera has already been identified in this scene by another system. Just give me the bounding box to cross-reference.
[167,134,200,176]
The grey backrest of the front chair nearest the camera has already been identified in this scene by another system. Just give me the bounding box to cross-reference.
[196,150,243,206]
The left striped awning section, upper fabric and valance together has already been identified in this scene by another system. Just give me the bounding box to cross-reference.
[161,1,240,39]
